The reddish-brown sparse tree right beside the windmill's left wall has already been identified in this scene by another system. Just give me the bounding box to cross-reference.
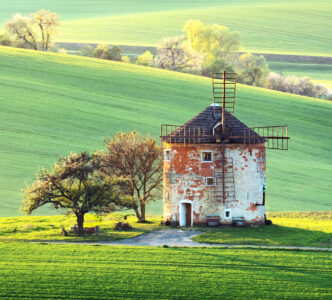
[103,131,163,222]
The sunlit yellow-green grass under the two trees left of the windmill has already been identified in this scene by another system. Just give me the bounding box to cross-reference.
[0,214,165,242]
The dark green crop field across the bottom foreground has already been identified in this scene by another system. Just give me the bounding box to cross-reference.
[0,243,332,299]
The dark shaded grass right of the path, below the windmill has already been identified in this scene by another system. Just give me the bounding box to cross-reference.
[194,225,332,247]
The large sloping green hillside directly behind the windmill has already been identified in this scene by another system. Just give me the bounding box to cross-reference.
[0,47,332,216]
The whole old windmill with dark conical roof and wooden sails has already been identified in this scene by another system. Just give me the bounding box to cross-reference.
[160,72,289,226]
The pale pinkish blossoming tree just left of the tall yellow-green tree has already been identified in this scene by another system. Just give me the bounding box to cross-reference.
[157,36,202,72]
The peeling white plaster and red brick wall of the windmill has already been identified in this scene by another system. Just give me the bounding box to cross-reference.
[163,144,266,224]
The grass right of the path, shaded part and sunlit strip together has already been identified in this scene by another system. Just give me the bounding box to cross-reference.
[194,212,332,248]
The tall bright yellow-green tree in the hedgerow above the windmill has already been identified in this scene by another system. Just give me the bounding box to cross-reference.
[183,20,241,74]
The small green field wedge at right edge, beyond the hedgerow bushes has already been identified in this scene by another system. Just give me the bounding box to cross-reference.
[269,62,332,90]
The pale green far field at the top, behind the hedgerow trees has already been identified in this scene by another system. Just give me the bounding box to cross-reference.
[0,0,332,56]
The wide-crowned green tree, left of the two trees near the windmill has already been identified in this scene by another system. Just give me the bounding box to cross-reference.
[22,152,133,236]
